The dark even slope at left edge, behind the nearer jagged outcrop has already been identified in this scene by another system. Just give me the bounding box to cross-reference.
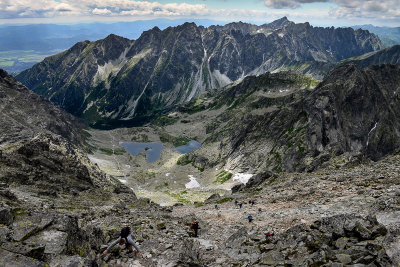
[0,69,85,145]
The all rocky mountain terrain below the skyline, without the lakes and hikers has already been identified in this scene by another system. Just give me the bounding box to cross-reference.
[0,17,400,267]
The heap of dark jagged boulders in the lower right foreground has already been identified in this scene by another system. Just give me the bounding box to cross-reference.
[260,215,393,266]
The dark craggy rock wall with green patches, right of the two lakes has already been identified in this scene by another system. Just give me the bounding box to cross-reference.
[177,64,400,172]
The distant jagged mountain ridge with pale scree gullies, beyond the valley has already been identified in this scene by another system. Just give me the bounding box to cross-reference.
[17,18,382,125]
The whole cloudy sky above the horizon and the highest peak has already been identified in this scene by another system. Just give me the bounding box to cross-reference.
[0,0,400,27]
